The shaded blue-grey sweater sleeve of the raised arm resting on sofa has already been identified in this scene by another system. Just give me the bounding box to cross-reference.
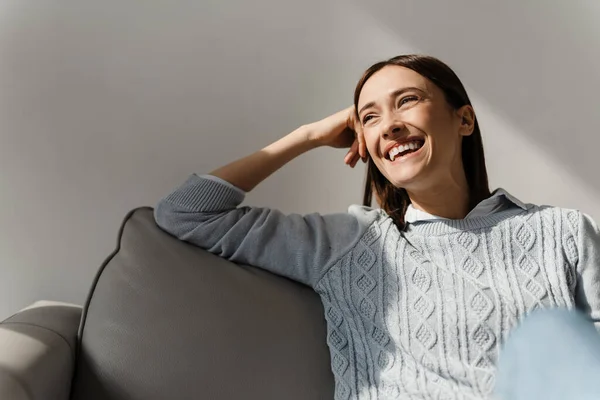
[154,175,378,286]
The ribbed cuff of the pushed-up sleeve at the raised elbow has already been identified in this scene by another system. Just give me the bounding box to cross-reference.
[165,174,245,212]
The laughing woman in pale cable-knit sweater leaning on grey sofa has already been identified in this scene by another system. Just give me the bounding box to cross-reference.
[155,55,600,399]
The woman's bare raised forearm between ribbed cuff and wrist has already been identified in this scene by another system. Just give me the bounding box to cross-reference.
[210,127,318,192]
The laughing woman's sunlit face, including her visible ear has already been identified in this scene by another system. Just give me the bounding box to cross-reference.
[357,66,474,190]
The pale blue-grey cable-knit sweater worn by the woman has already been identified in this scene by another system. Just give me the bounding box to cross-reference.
[155,175,600,400]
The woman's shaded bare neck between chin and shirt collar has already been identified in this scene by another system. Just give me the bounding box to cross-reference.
[407,182,471,219]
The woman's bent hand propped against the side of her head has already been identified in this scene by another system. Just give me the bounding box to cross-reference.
[307,106,367,168]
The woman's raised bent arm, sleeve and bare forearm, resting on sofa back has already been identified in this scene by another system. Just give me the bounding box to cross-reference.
[155,108,380,285]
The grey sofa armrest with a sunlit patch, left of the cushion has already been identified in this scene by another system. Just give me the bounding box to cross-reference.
[0,301,81,400]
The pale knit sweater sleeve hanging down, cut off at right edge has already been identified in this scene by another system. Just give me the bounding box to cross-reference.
[575,214,600,331]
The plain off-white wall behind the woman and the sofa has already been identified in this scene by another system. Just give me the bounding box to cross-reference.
[0,0,600,318]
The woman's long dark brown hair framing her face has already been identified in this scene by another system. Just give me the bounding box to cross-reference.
[354,54,490,229]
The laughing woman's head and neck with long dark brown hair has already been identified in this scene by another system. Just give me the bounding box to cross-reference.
[354,55,490,228]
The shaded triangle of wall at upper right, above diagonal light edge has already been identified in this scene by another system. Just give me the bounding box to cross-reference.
[355,0,600,197]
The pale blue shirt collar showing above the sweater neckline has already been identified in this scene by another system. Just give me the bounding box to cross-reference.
[404,189,527,224]
